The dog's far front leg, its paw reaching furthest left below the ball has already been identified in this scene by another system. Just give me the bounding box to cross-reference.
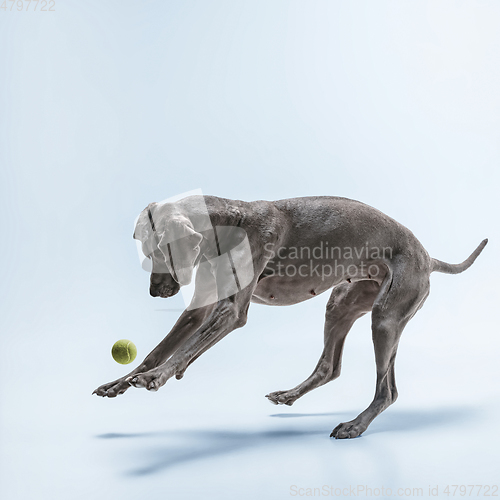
[92,306,213,398]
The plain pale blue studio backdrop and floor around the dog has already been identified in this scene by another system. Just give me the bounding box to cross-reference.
[0,0,500,500]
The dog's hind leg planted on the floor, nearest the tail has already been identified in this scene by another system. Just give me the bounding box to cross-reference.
[330,266,429,439]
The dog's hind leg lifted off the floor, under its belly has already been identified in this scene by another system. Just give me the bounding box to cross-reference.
[266,281,380,406]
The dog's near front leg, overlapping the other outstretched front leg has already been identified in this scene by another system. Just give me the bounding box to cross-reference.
[127,292,249,391]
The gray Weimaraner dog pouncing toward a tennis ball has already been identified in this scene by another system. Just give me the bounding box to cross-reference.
[94,195,488,438]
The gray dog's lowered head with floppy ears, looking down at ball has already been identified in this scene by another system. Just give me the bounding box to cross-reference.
[134,203,203,297]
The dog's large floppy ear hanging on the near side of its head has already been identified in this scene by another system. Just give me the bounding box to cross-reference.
[158,218,203,286]
